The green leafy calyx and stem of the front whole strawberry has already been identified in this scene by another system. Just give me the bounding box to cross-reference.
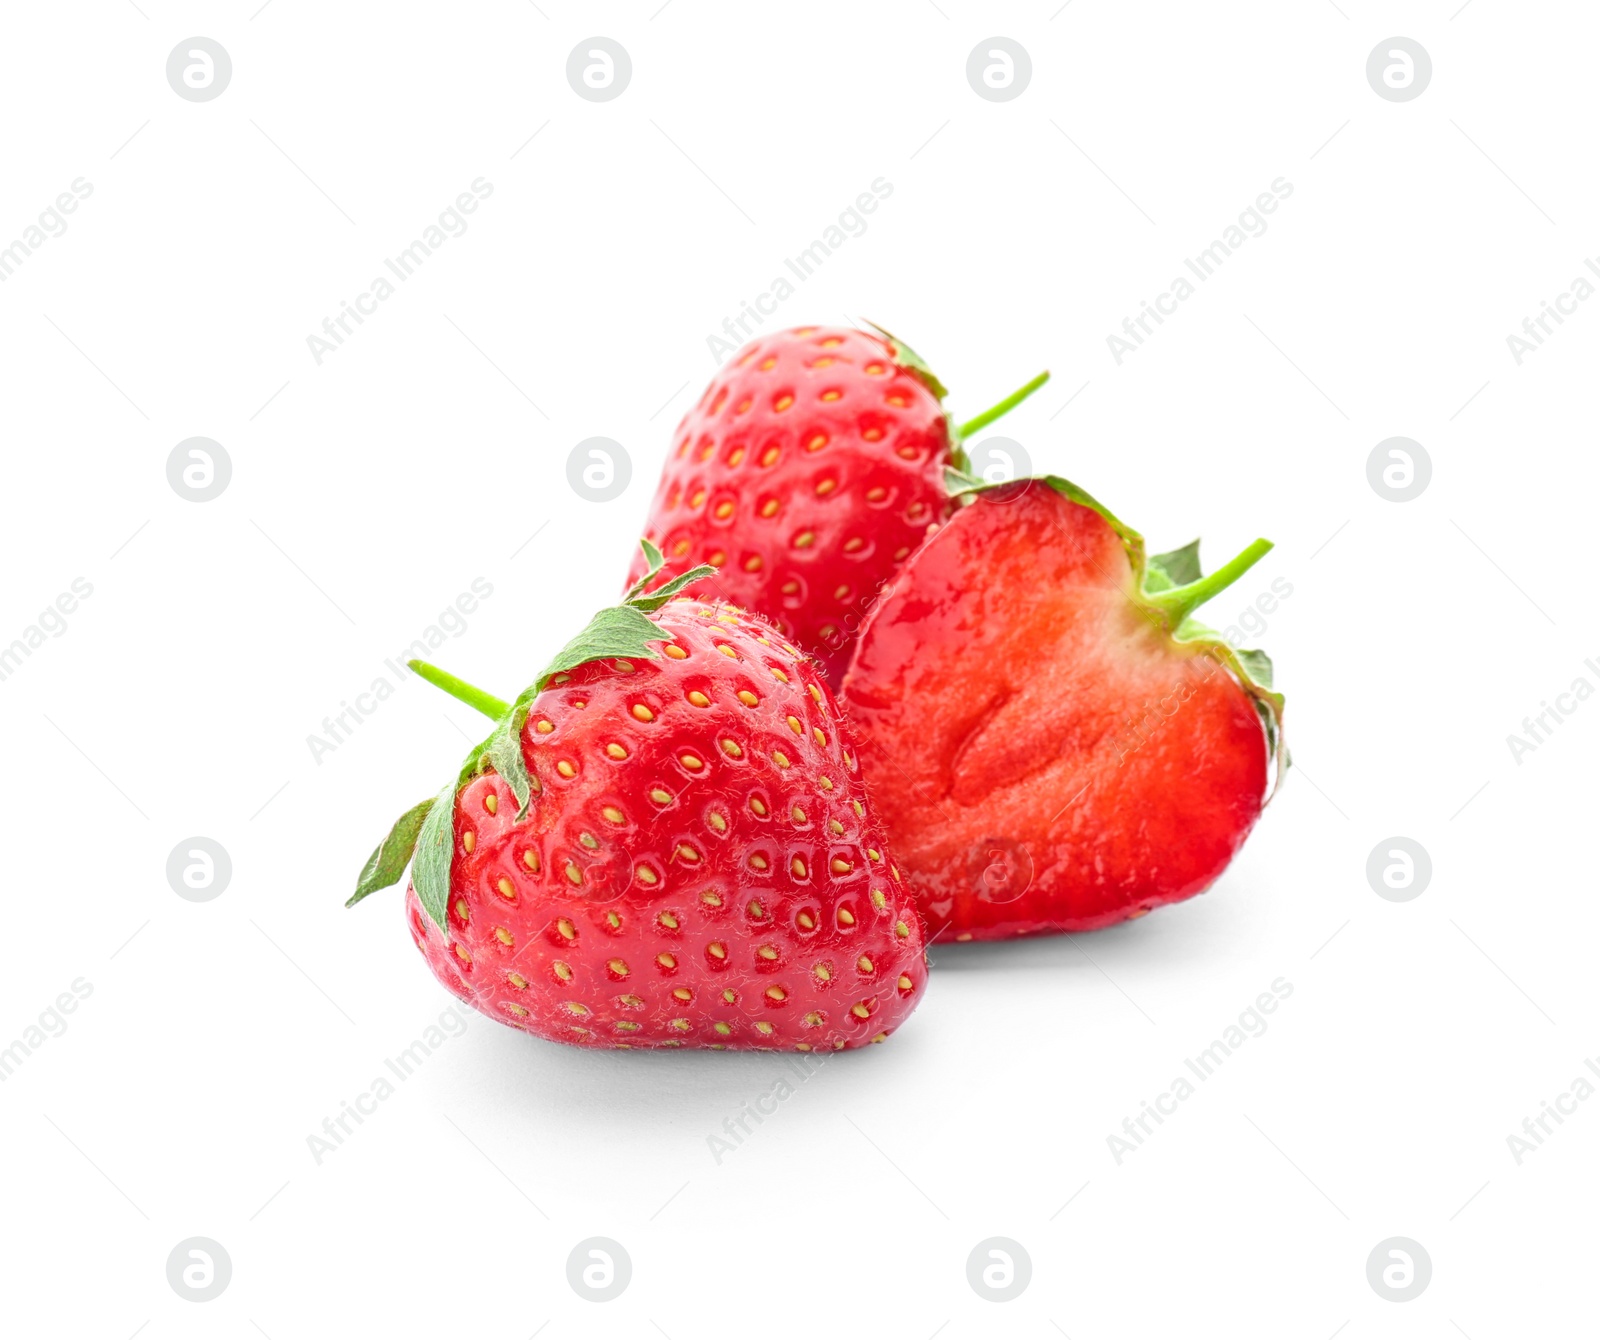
[346,540,717,931]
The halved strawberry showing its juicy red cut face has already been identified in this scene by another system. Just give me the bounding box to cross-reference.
[840,480,1286,940]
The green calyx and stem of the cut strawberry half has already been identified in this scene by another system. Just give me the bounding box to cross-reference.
[946,470,1290,786]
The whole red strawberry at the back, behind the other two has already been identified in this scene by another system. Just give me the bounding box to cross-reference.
[629,326,1050,683]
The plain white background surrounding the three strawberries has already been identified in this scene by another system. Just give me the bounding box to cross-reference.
[0,0,1600,1340]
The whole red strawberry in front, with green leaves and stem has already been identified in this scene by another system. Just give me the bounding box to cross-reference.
[350,548,926,1051]
